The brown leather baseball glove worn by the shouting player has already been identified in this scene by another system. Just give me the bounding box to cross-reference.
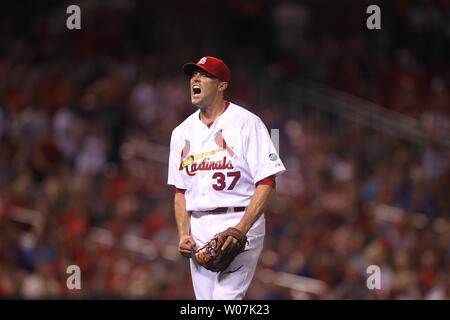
[195,228,247,272]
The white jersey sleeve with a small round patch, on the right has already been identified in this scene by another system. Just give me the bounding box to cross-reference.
[246,120,286,183]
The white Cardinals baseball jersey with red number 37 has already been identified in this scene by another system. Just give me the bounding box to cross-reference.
[168,103,286,211]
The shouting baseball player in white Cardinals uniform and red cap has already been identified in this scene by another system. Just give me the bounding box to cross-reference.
[168,56,285,300]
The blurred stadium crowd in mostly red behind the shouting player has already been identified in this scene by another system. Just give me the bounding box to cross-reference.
[0,0,450,299]
